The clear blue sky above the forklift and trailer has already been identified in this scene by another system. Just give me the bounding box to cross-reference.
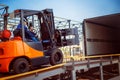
[0,0,120,21]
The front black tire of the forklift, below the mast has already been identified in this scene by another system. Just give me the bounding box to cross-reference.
[50,49,63,65]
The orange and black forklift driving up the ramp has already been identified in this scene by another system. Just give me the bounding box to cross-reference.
[0,6,79,74]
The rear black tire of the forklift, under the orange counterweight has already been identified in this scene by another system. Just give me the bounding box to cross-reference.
[13,58,30,74]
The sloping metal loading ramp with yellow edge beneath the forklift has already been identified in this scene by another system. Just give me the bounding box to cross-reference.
[0,54,120,80]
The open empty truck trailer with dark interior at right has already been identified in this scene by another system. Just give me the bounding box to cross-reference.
[83,13,120,56]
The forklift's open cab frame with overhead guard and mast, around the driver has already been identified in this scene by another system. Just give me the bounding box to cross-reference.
[14,9,55,50]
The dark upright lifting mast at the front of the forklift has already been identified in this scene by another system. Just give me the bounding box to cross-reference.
[39,9,55,47]
